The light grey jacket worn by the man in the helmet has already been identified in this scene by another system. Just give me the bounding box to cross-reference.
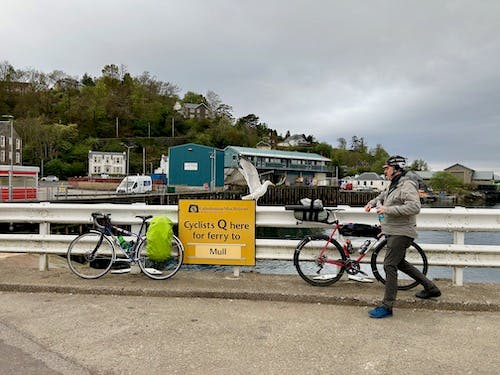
[368,172,420,238]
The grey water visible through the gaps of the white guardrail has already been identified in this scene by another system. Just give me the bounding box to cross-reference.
[187,204,500,284]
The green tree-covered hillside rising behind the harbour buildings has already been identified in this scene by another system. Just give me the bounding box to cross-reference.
[0,61,426,178]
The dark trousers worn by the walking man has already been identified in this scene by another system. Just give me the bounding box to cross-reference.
[382,236,437,309]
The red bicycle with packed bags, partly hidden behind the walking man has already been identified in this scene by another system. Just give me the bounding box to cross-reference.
[286,206,428,290]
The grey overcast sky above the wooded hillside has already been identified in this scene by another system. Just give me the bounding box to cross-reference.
[0,0,500,174]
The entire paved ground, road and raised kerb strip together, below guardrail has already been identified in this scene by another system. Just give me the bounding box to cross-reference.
[0,255,500,375]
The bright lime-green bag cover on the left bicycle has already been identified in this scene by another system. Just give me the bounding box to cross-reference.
[146,216,174,262]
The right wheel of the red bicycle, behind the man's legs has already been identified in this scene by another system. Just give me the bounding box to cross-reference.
[371,239,429,290]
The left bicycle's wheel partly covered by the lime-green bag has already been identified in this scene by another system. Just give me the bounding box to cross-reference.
[137,235,184,280]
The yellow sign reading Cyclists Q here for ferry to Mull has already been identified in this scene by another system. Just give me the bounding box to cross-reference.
[179,200,255,266]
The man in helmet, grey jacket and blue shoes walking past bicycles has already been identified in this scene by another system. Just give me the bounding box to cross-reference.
[365,156,441,318]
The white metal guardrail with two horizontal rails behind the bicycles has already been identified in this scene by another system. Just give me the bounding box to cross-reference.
[0,202,500,285]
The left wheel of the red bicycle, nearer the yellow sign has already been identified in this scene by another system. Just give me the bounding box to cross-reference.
[293,235,346,286]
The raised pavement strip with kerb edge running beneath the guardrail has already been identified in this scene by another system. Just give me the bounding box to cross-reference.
[0,254,500,311]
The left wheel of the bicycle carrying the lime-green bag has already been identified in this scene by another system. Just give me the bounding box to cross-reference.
[66,231,115,279]
